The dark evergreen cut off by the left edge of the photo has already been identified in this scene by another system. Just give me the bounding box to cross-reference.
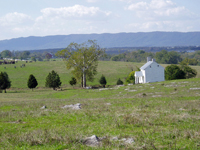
[0,72,11,93]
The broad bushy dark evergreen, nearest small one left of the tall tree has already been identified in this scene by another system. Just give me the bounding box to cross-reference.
[45,70,62,90]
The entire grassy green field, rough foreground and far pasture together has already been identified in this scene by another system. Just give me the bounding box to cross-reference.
[0,61,200,150]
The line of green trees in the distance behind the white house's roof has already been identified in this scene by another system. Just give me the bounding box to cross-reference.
[111,50,200,65]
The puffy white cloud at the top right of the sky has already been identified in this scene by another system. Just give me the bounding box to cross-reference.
[126,0,194,20]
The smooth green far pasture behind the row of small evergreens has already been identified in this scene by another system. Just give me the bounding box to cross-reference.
[0,60,200,88]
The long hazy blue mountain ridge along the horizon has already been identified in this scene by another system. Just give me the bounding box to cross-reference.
[0,32,200,51]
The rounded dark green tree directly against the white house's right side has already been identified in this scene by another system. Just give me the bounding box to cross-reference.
[165,64,186,80]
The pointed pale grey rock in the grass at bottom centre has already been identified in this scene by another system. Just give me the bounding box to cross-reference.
[83,135,101,147]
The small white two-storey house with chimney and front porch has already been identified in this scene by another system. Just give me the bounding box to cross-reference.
[135,57,165,84]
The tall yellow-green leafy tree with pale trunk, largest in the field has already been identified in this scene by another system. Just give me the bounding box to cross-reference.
[56,40,104,88]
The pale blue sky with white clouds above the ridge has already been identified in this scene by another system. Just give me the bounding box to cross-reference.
[0,0,200,40]
